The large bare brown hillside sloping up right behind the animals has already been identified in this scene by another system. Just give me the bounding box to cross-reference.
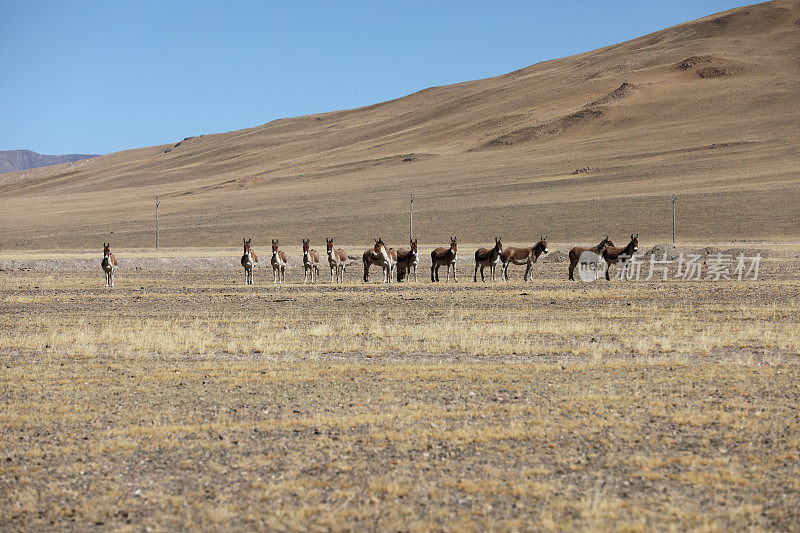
[0,0,800,248]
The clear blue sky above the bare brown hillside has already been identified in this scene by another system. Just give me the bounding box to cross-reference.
[0,0,746,154]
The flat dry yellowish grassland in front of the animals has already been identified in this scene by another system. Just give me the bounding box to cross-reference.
[0,259,800,530]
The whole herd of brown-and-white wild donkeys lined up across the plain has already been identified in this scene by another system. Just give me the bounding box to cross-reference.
[102,234,639,287]
